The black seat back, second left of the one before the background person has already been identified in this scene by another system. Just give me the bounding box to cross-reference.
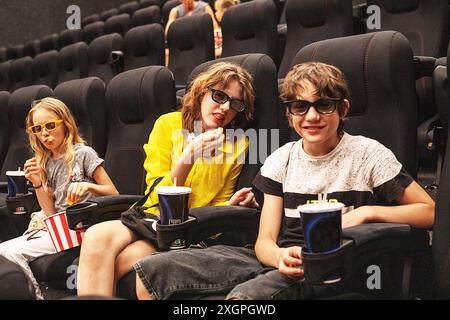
[89,33,124,84]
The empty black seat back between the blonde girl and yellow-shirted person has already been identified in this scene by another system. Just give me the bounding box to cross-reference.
[105,66,176,194]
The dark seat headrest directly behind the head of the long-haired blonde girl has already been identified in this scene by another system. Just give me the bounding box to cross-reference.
[8,85,52,129]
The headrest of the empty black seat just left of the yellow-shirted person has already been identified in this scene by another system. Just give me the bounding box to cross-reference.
[106,66,175,124]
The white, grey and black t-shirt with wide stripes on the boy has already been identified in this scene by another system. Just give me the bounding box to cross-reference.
[253,133,413,247]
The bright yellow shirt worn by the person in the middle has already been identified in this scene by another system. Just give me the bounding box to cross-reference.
[144,112,248,215]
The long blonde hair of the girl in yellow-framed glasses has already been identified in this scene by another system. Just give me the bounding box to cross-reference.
[25,97,85,190]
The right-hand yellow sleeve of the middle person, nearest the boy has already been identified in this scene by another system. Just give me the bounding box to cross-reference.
[210,139,248,206]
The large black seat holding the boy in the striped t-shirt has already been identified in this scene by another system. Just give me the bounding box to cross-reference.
[292,31,430,299]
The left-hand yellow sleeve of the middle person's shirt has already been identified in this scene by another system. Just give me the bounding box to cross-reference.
[144,117,173,214]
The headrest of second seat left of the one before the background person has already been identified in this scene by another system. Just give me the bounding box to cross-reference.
[89,33,123,64]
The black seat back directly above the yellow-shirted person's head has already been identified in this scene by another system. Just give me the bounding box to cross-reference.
[222,0,277,61]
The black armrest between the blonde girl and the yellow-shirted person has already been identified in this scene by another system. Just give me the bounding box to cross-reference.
[66,195,142,230]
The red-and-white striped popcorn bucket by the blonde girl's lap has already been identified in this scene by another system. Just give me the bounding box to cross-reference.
[44,211,86,252]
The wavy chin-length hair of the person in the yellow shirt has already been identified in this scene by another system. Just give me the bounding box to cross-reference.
[181,62,255,132]
